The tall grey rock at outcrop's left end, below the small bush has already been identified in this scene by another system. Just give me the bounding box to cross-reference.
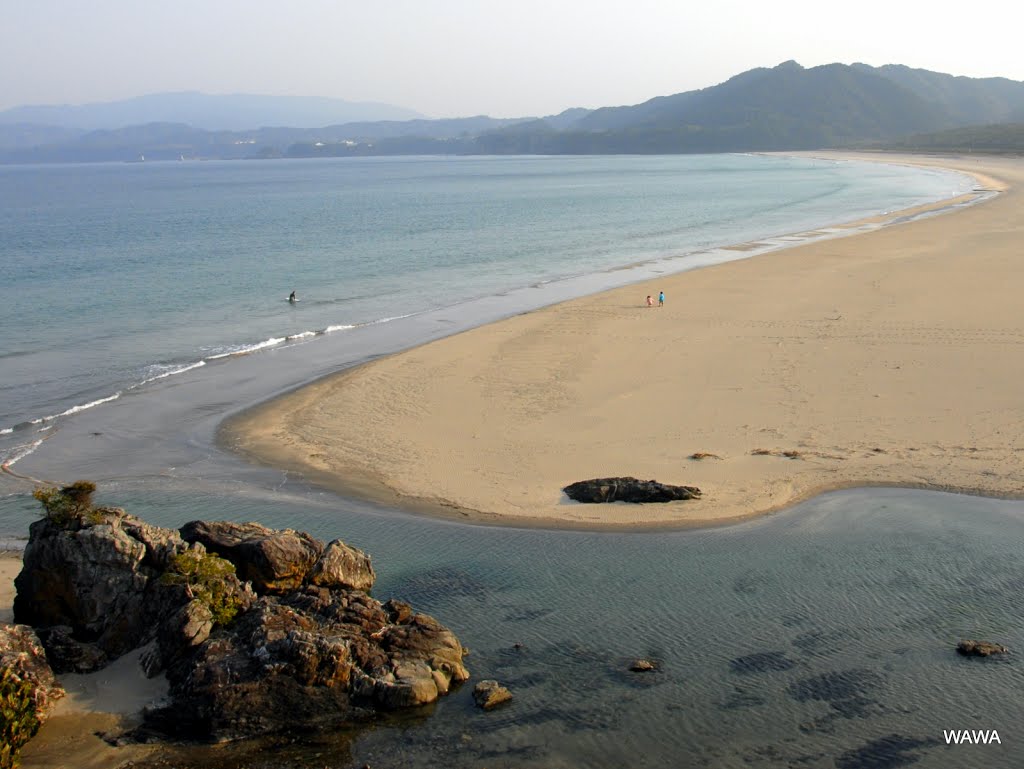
[14,508,188,673]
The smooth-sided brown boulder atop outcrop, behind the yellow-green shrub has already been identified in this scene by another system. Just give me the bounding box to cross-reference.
[181,521,323,595]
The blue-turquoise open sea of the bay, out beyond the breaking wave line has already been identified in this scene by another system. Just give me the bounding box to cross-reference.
[0,156,970,461]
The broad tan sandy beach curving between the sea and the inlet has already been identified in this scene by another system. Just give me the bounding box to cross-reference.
[221,154,1024,528]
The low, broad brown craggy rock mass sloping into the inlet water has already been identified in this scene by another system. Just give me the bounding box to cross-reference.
[148,586,469,740]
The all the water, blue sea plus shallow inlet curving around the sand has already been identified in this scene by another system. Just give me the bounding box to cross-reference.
[0,156,1024,769]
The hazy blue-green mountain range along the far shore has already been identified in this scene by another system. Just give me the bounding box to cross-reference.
[0,61,1024,163]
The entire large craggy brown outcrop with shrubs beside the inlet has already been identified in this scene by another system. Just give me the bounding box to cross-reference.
[15,493,469,740]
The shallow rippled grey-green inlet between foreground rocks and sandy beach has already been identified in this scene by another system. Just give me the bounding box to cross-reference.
[0,489,1024,769]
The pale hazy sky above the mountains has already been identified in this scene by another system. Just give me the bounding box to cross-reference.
[0,0,1024,117]
